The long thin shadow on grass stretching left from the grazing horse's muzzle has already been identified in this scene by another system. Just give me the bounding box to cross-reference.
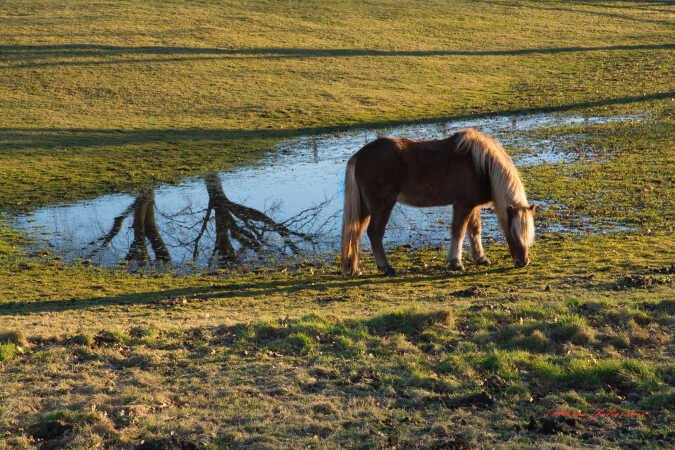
[0,267,517,317]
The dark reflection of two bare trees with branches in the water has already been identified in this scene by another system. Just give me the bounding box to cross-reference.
[90,173,336,267]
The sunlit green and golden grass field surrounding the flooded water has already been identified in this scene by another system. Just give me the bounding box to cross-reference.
[0,0,675,448]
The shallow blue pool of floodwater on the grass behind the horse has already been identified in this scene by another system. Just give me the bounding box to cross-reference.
[14,114,640,267]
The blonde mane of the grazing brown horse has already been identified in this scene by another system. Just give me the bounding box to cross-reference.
[457,128,534,242]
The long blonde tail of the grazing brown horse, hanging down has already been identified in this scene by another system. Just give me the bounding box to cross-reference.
[341,155,368,275]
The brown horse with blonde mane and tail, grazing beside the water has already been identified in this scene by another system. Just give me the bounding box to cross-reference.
[342,129,534,275]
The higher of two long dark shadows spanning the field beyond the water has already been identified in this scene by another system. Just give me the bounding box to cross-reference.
[0,43,675,70]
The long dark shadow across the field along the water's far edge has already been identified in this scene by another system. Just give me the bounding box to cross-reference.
[0,91,675,150]
